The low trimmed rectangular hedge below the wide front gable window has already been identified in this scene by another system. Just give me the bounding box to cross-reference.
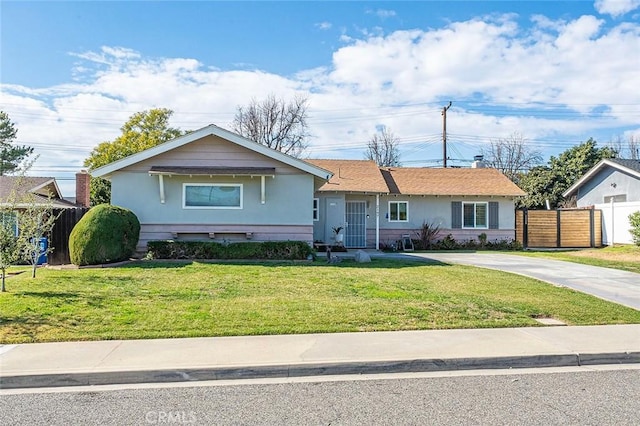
[147,241,313,260]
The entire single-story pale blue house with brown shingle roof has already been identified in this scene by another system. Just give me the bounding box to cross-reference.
[91,125,524,250]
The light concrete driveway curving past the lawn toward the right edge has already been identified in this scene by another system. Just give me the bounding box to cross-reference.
[406,252,640,310]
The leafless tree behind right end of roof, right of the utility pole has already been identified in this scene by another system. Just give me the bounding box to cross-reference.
[482,132,542,183]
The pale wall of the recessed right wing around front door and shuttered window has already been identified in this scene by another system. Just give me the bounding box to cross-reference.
[314,193,515,248]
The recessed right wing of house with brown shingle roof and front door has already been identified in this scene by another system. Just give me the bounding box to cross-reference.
[307,160,525,248]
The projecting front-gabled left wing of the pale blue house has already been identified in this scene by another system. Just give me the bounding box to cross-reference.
[91,125,331,250]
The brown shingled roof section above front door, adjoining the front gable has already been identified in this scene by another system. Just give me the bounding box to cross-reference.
[306,159,389,194]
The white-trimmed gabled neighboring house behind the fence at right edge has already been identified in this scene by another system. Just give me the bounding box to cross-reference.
[562,158,640,207]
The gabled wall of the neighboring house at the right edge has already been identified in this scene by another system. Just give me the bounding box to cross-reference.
[577,167,640,207]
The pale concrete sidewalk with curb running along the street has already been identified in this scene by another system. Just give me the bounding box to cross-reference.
[0,325,640,389]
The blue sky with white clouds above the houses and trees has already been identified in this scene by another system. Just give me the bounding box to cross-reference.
[0,0,640,193]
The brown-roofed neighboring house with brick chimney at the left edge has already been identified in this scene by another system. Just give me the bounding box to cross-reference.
[0,172,89,235]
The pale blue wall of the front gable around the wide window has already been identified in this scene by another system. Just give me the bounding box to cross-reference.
[111,137,314,250]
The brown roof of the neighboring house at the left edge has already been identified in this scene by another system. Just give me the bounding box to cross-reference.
[0,176,75,208]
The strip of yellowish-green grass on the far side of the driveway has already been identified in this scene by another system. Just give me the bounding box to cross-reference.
[514,245,640,273]
